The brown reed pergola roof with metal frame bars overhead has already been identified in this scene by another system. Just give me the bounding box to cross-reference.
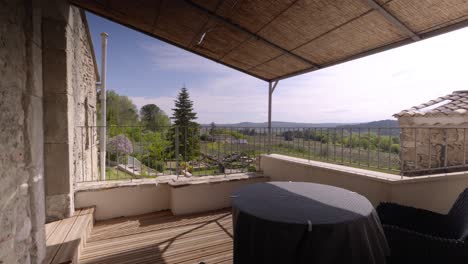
[70,0,468,81]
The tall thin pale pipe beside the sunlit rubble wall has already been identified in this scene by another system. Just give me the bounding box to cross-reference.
[99,32,108,181]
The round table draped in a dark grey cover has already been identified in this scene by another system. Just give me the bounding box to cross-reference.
[232,182,389,264]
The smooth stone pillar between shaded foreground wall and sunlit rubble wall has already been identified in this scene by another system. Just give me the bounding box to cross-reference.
[42,1,74,221]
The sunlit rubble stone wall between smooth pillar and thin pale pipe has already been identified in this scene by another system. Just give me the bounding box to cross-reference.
[70,8,99,186]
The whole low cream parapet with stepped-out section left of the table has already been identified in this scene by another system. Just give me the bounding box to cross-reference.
[75,173,268,220]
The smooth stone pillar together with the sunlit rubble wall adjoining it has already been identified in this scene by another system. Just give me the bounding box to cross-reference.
[42,0,97,221]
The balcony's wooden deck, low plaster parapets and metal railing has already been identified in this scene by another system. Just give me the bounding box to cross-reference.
[44,127,468,263]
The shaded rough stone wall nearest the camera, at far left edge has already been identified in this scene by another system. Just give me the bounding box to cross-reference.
[0,0,45,264]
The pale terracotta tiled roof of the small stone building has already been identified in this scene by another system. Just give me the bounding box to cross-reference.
[393,90,468,118]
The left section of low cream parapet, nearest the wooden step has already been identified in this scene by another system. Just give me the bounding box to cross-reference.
[75,184,170,220]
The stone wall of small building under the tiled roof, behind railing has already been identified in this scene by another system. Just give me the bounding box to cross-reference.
[399,117,468,176]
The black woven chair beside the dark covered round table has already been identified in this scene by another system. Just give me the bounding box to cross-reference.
[377,188,468,263]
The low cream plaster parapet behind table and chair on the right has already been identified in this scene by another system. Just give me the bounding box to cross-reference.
[260,155,468,213]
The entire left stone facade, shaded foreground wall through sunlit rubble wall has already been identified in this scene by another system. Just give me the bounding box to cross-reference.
[0,0,98,264]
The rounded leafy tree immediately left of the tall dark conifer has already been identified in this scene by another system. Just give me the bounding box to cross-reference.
[140,104,171,132]
